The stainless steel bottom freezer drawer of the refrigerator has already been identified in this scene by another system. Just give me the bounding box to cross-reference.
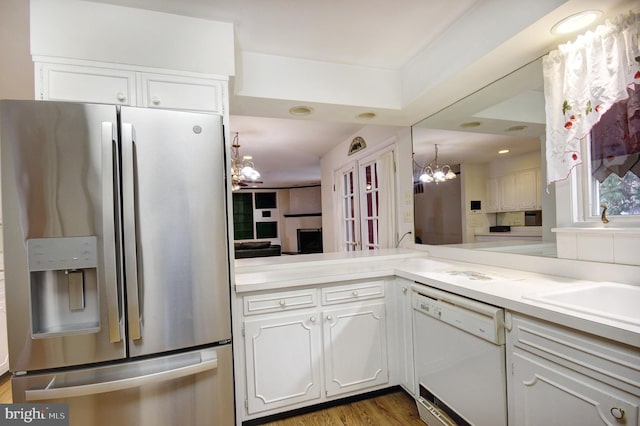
[12,345,234,426]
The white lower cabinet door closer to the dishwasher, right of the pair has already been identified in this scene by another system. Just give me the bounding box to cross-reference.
[323,303,389,396]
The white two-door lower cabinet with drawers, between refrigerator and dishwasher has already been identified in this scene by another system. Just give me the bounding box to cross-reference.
[243,280,389,417]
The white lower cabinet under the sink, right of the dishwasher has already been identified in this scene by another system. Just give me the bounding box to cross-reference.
[507,315,640,426]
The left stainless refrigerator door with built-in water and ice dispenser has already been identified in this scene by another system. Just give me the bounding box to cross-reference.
[0,101,126,371]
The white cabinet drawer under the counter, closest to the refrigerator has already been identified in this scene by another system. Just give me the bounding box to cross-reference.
[243,289,318,315]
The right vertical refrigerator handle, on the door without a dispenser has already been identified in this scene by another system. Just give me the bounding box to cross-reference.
[121,123,142,340]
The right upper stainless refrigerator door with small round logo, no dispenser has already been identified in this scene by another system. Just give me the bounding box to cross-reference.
[120,107,231,356]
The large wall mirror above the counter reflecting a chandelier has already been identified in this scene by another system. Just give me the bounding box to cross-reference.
[412,59,555,257]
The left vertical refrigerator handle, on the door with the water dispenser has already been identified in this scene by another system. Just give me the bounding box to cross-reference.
[102,122,122,343]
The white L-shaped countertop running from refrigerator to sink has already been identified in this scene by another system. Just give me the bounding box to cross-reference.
[235,249,640,348]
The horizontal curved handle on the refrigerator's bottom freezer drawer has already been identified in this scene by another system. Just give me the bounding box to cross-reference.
[25,351,218,402]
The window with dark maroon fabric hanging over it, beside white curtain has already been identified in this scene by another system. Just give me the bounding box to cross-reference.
[587,85,640,218]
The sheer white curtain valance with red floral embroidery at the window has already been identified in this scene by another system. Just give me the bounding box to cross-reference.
[542,13,640,184]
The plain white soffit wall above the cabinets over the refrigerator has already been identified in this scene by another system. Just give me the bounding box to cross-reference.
[30,0,235,76]
